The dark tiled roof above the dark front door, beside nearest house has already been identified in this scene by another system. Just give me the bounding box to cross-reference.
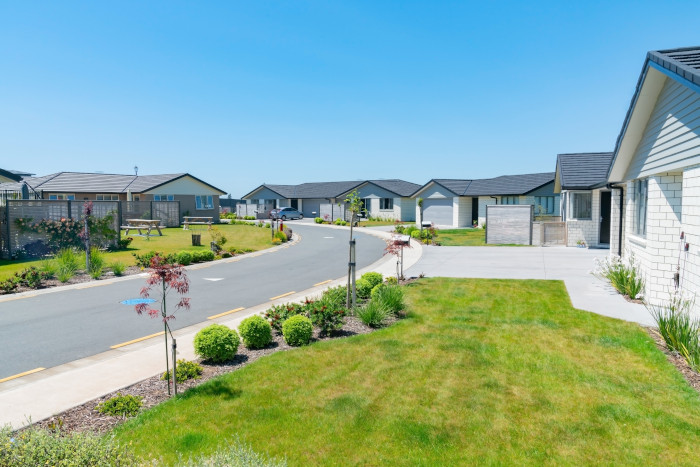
[557,152,613,190]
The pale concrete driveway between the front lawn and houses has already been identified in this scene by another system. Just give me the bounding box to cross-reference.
[405,246,655,325]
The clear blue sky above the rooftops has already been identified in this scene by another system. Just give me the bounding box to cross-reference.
[0,0,700,198]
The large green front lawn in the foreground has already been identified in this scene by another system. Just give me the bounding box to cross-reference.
[110,279,700,465]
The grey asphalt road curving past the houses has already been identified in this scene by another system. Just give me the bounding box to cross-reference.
[0,222,385,379]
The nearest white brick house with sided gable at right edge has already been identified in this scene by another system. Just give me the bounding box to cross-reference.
[608,47,700,306]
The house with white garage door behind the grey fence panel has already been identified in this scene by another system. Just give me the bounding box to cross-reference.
[412,172,559,228]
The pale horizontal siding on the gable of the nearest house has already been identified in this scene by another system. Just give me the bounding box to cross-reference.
[625,79,700,180]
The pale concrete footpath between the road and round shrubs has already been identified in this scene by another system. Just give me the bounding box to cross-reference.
[0,226,422,428]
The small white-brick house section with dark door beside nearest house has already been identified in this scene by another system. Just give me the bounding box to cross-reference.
[554,152,612,248]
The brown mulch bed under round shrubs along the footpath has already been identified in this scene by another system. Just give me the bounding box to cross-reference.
[33,316,382,434]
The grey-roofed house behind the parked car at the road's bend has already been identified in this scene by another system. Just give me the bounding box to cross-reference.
[243,179,420,222]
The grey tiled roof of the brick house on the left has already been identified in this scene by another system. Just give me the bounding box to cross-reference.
[17,172,223,193]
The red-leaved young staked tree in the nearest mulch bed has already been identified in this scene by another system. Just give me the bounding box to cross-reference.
[136,254,190,394]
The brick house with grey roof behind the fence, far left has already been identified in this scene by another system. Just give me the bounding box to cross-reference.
[0,172,226,221]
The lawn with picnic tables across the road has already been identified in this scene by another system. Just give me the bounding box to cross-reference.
[0,224,272,280]
